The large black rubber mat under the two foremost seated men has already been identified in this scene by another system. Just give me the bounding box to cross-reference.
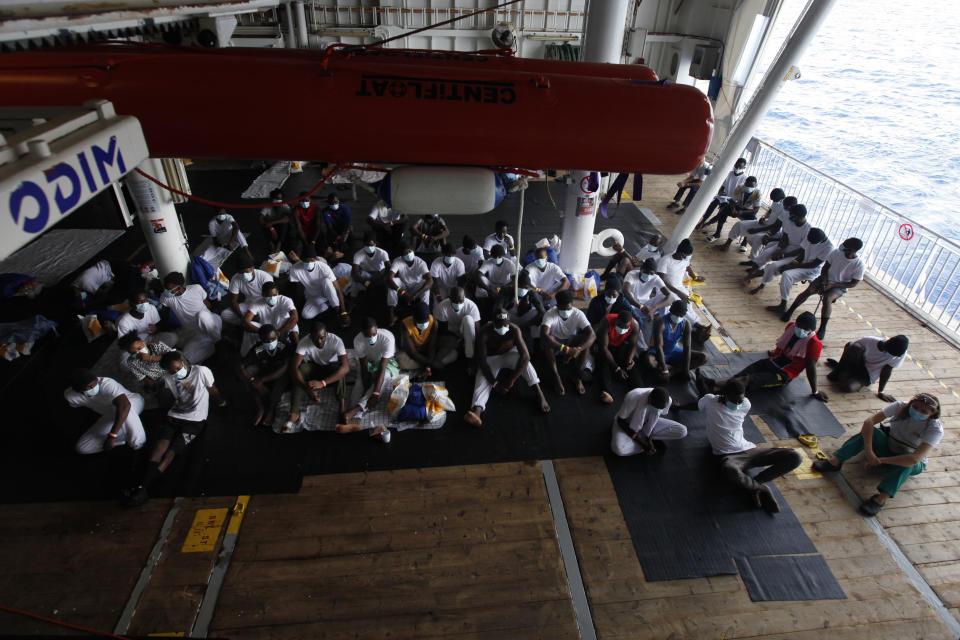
[606,411,816,582]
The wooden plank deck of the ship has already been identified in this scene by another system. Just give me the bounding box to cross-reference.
[0,176,960,640]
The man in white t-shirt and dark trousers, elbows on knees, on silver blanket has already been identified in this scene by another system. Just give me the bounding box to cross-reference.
[283,320,350,433]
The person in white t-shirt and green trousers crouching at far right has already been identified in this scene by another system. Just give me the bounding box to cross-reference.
[813,393,943,516]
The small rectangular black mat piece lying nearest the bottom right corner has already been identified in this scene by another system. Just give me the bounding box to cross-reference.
[737,555,847,602]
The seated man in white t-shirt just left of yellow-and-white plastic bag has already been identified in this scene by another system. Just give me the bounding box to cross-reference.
[337,316,399,433]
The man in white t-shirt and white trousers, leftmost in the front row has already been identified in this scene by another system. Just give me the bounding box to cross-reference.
[63,369,147,454]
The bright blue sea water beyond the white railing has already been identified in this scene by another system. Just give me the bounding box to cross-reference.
[755,0,960,241]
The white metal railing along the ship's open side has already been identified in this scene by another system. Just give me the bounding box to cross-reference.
[746,138,960,347]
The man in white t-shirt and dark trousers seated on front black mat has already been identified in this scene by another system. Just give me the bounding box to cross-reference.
[697,379,803,513]
